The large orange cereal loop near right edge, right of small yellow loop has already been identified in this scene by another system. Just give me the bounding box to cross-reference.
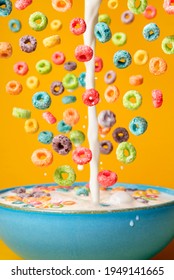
[149,57,167,76]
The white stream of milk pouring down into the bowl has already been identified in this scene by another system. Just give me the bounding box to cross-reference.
[84,0,102,204]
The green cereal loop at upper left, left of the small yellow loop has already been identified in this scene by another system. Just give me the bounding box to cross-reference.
[29,12,48,31]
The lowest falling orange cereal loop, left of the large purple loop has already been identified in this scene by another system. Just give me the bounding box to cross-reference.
[31,148,53,167]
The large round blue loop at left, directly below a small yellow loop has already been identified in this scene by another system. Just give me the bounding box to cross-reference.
[32,91,51,110]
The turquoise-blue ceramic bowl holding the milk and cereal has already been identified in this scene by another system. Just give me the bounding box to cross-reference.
[0,183,174,260]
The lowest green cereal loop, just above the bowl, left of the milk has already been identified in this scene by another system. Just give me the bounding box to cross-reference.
[54,165,76,186]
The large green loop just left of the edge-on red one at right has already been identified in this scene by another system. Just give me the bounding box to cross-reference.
[123,90,142,110]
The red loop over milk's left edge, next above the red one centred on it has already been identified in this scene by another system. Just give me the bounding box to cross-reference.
[75,45,93,62]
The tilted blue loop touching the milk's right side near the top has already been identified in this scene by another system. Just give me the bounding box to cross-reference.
[94,22,112,43]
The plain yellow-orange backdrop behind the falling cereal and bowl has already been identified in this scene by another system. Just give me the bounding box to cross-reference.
[0,0,174,259]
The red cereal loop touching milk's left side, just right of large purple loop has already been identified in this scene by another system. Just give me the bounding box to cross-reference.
[72,147,92,165]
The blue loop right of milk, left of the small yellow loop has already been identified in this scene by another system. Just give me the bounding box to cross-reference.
[113,50,132,69]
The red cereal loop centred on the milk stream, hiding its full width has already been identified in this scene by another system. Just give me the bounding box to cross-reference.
[82,88,100,106]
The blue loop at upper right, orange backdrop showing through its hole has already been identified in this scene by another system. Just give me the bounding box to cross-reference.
[143,23,160,41]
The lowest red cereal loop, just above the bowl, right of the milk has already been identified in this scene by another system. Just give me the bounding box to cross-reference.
[98,170,118,187]
